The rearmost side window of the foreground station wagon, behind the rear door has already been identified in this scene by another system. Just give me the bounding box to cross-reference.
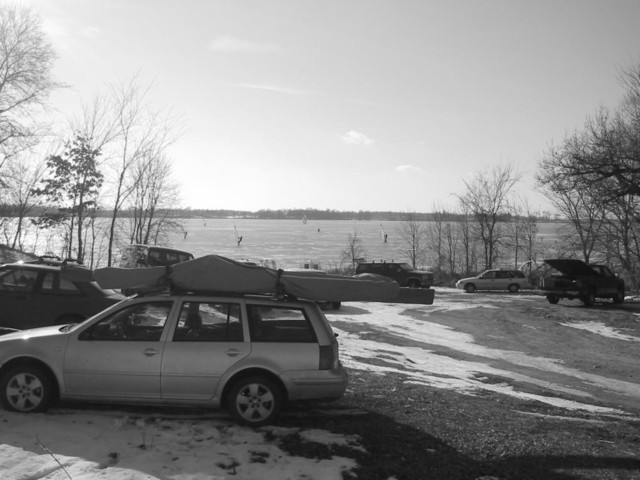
[247,305,317,343]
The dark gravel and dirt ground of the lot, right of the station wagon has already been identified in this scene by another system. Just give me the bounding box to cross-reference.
[283,289,640,480]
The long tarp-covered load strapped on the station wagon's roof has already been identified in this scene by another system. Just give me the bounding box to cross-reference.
[93,255,400,302]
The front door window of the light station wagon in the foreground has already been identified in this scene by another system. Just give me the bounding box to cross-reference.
[80,301,173,342]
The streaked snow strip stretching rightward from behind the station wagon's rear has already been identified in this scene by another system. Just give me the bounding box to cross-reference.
[333,297,640,414]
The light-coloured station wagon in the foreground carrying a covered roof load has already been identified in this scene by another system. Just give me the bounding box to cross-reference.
[0,294,347,426]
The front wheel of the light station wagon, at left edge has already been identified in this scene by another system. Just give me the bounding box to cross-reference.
[0,365,53,413]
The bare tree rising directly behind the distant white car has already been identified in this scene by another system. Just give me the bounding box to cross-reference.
[458,164,520,268]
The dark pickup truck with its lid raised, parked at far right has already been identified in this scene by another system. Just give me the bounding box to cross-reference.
[539,258,625,307]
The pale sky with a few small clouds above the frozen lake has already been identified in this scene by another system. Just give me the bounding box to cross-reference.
[16,0,640,212]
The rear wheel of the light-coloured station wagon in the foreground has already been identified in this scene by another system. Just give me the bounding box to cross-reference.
[227,377,283,427]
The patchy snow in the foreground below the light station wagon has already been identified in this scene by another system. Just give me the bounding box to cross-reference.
[0,410,362,480]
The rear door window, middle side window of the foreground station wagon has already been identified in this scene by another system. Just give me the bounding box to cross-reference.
[173,302,244,342]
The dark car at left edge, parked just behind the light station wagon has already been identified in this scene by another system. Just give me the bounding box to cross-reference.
[0,257,125,333]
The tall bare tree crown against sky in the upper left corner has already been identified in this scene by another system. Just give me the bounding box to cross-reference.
[0,4,61,172]
